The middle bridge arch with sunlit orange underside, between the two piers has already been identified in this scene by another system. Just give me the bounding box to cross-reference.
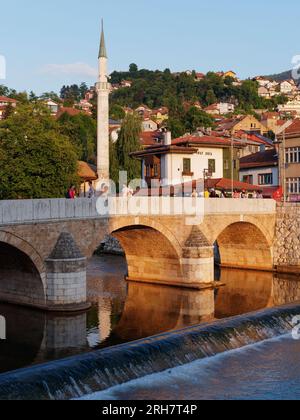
[111,218,183,284]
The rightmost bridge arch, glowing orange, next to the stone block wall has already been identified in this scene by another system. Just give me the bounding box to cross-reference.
[215,219,273,271]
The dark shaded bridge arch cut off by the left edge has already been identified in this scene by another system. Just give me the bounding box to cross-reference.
[0,231,46,307]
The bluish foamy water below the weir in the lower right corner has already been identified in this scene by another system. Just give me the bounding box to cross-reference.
[79,334,300,400]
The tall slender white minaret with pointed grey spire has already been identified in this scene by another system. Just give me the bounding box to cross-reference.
[96,21,110,181]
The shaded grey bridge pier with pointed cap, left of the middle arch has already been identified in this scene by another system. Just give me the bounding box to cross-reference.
[45,232,90,311]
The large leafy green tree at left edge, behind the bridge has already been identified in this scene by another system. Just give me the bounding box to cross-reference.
[0,104,78,199]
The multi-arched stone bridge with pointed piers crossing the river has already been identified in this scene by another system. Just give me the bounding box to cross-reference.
[0,197,288,311]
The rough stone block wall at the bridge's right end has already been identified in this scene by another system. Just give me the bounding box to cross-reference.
[274,203,300,274]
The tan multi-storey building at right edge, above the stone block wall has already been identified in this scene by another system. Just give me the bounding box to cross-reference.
[277,119,300,201]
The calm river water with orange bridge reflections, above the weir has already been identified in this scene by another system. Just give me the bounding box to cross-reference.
[0,256,300,373]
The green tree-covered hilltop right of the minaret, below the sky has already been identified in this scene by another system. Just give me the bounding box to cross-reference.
[111,64,285,116]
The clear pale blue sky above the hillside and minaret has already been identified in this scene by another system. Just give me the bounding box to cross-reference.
[0,0,300,94]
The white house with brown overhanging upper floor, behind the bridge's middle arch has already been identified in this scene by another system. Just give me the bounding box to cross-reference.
[132,133,242,185]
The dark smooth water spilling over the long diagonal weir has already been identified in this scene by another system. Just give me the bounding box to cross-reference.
[0,304,300,400]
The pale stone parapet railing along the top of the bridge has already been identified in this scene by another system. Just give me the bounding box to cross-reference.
[0,197,276,226]
